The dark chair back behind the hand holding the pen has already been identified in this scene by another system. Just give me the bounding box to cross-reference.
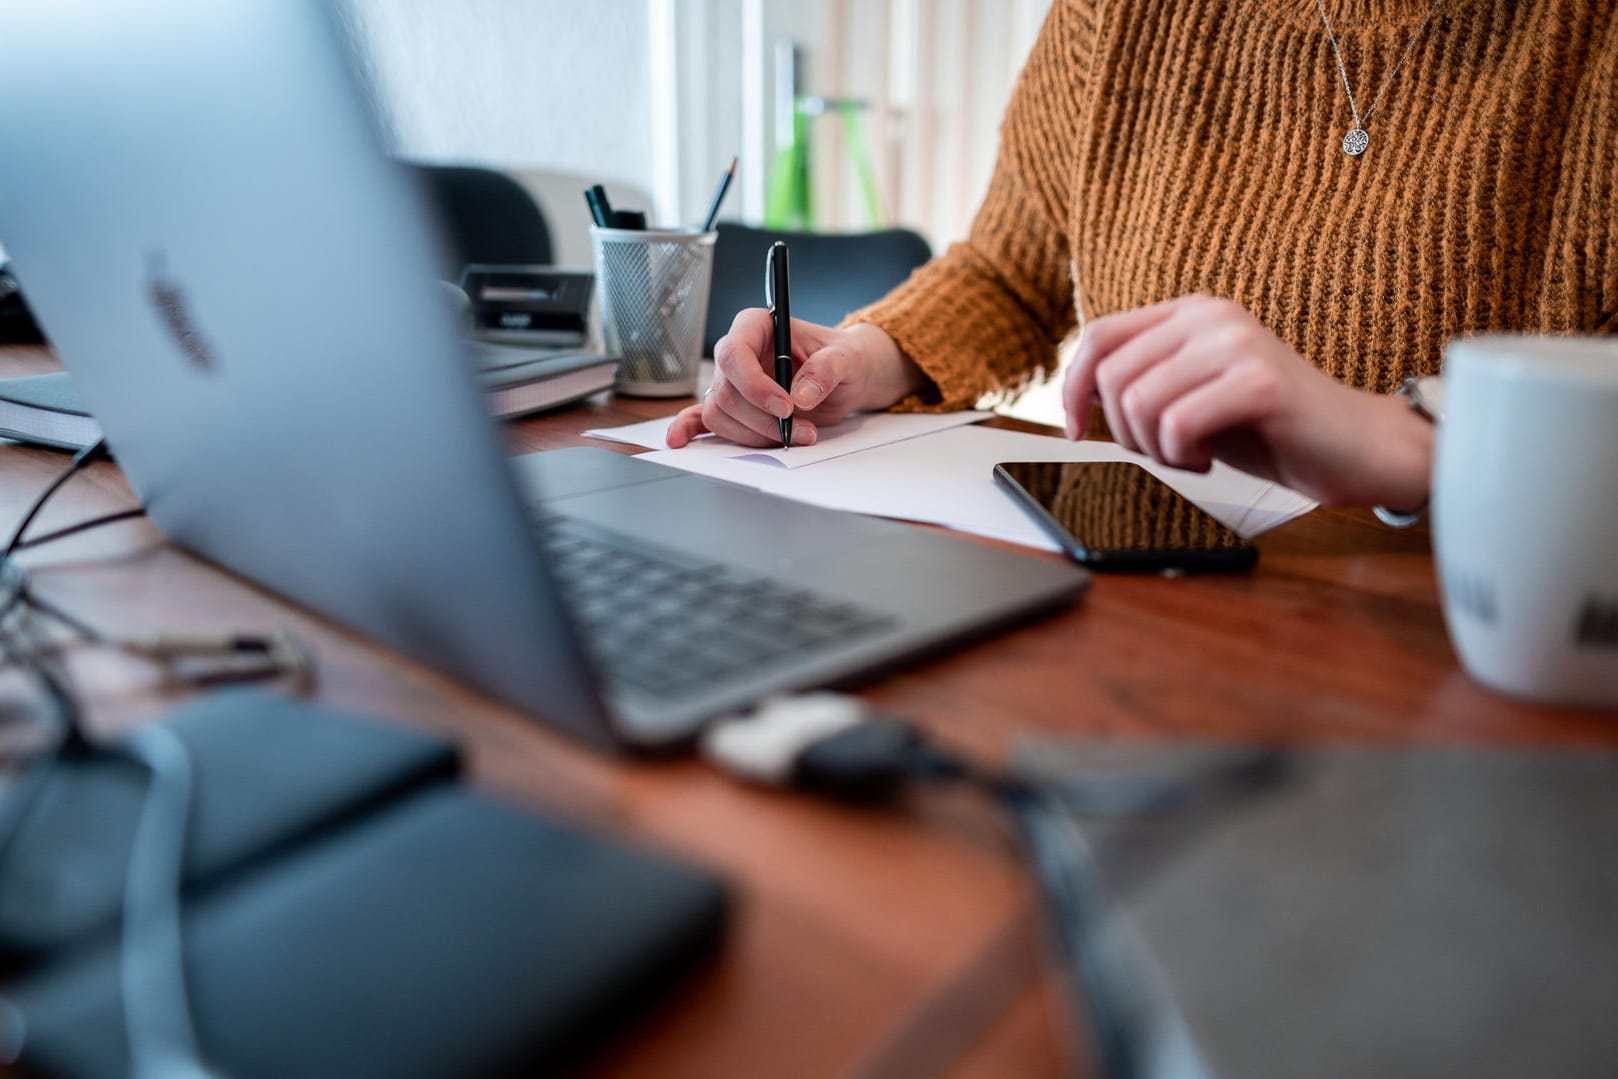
[702,222,932,356]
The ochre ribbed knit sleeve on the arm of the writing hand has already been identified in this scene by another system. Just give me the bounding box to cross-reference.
[848,0,1094,411]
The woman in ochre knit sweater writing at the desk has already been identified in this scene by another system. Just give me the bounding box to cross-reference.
[668,0,1618,508]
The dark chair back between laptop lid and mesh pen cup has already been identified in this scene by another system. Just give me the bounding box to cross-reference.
[411,163,552,281]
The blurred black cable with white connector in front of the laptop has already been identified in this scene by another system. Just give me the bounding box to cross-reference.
[704,708,1288,1079]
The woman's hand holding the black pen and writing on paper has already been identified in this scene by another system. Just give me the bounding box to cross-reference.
[668,307,927,450]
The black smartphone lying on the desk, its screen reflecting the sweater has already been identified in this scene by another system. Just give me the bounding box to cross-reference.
[995,461,1259,573]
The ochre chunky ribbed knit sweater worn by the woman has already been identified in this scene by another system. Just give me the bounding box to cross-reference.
[854,0,1618,408]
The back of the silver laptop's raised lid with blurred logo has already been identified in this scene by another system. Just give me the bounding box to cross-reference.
[0,0,607,741]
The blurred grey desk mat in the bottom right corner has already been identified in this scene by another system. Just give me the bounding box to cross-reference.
[1024,744,1618,1079]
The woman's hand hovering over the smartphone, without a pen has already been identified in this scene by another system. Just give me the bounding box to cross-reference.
[1063,296,1432,508]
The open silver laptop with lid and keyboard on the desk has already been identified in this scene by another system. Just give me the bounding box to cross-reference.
[0,0,1086,746]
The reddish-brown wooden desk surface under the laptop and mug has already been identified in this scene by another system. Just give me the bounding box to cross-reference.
[0,348,1618,1079]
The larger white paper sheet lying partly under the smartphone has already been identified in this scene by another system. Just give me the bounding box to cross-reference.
[646,427,1314,550]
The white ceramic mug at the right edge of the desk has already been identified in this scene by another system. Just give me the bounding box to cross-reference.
[1432,336,1618,709]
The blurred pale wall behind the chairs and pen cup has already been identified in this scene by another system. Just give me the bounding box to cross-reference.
[346,0,1048,248]
